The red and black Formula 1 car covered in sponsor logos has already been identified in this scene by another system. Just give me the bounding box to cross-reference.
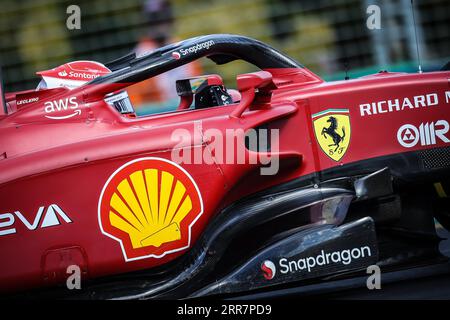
[0,35,450,298]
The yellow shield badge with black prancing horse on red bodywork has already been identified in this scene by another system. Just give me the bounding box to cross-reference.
[312,109,351,161]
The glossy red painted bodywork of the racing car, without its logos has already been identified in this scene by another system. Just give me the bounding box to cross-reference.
[0,69,450,290]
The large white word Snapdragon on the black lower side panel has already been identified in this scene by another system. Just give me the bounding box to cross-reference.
[278,246,372,274]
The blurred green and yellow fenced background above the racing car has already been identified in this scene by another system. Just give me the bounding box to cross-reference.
[0,0,450,91]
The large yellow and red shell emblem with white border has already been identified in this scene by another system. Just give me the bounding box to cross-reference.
[98,157,203,261]
